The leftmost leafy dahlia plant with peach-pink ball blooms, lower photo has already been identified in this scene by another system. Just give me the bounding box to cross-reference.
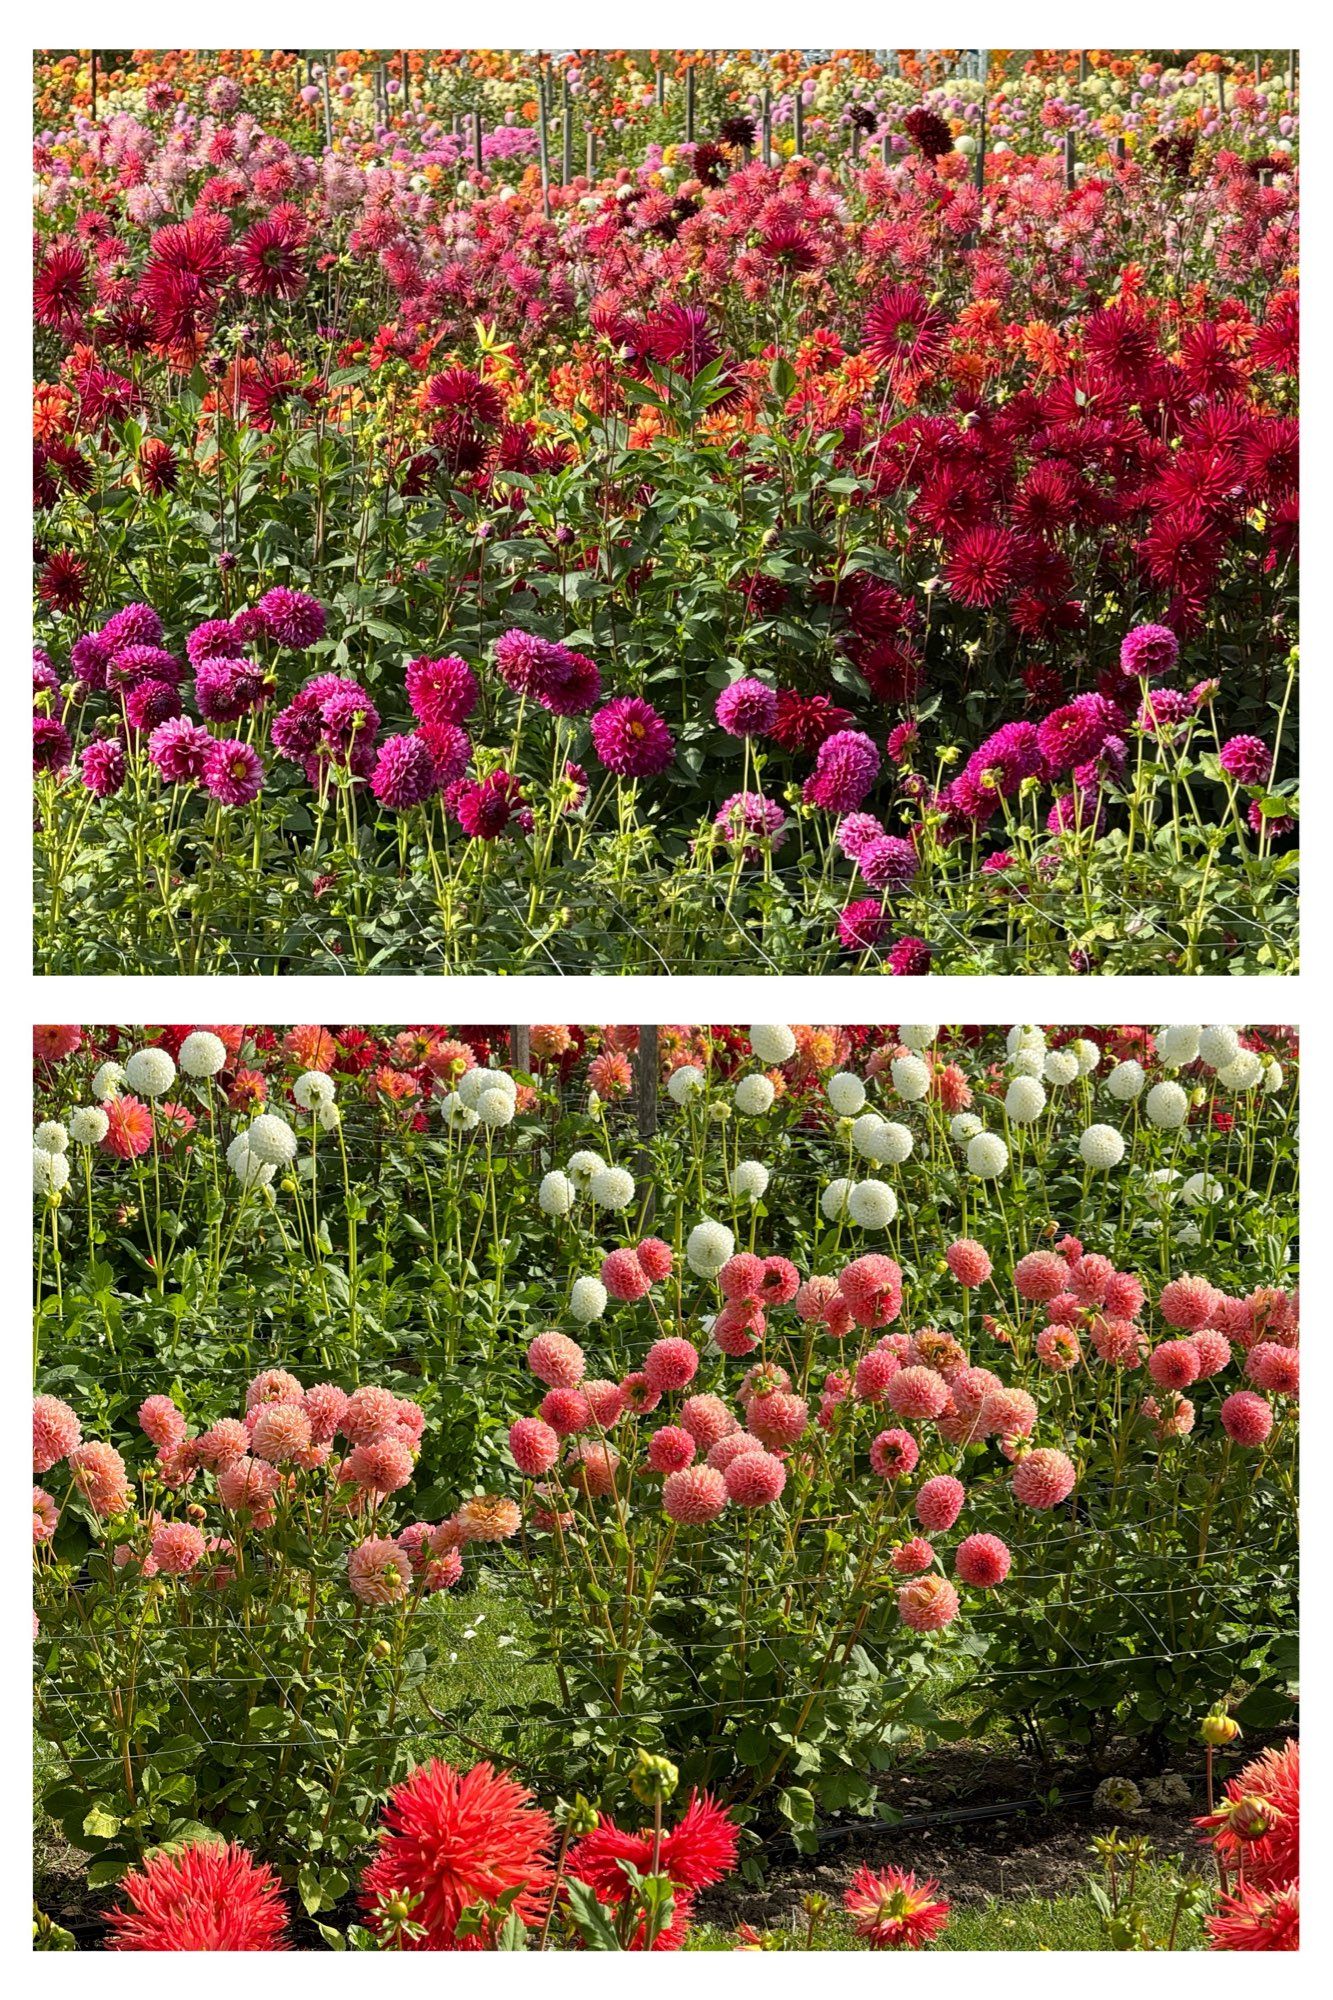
[32,1368,504,1912]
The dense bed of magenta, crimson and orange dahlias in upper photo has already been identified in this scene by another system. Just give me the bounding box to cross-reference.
[34,52,1297,972]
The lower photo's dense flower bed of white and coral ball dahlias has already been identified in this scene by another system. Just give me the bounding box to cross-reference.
[34,1024,1299,1880]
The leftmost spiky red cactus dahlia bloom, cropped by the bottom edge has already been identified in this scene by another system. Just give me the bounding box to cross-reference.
[106,1840,288,1952]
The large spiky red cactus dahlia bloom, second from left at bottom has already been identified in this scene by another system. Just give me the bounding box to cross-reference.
[360,1758,552,1952]
